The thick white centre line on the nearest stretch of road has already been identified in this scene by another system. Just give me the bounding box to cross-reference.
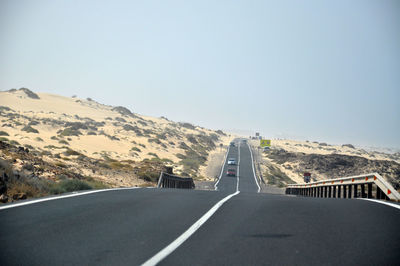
[142,191,240,266]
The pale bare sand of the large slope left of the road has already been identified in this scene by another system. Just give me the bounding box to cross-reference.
[0,90,230,185]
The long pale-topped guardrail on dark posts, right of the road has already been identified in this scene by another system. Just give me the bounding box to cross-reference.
[286,173,400,202]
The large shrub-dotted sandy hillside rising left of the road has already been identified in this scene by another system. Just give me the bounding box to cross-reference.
[0,89,231,196]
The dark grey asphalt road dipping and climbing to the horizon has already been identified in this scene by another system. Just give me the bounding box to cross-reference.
[0,140,400,265]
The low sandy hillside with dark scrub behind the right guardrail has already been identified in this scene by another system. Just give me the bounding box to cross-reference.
[252,140,400,188]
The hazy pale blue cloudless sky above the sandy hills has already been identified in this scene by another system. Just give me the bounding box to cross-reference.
[0,0,400,148]
